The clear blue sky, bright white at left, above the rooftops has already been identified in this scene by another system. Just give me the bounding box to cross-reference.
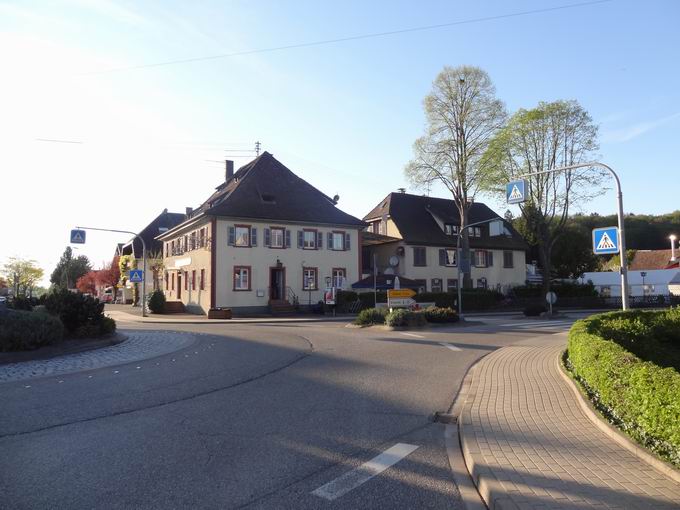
[0,0,680,283]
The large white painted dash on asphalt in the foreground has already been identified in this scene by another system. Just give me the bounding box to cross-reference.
[312,443,419,501]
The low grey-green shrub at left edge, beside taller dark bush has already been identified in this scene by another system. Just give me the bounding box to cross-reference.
[0,310,64,352]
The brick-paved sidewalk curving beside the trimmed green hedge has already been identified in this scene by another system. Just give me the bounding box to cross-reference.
[459,335,680,509]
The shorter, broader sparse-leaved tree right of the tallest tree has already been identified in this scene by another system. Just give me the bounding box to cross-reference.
[484,101,604,291]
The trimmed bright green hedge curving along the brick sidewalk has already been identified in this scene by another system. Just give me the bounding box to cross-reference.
[566,309,680,466]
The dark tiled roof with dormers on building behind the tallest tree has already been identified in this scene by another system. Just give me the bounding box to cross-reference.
[364,193,527,250]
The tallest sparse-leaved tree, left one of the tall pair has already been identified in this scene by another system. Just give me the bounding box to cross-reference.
[405,66,507,287]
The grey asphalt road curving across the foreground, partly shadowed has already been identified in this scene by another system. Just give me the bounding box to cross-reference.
[0,317,580,509]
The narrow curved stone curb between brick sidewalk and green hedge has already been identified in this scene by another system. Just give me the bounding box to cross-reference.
[555,351,680,483]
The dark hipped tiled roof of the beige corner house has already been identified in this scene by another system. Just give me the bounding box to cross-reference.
[193,152,365,227]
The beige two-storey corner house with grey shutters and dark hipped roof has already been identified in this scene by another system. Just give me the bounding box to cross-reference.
[158,153,365,314]
